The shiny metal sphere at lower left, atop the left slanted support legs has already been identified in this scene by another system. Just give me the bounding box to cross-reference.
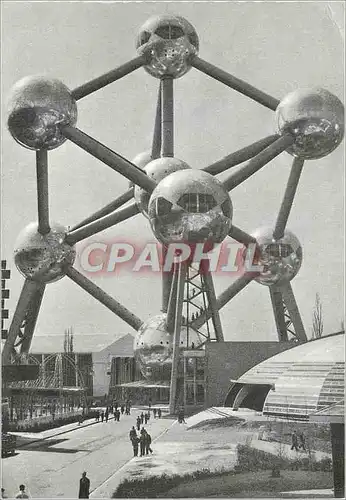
[14,222,76,283]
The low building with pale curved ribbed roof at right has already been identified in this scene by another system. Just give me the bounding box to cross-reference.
[225,332,345,420]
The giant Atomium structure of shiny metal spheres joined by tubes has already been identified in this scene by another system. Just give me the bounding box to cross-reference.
[3,15,344,402]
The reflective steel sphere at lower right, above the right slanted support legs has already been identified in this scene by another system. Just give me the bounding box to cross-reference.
[252,228,303,286]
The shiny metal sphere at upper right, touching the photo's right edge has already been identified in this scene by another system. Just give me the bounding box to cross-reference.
[276,88,344,160]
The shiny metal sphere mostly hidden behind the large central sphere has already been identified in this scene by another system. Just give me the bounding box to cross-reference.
[135,157,191,217]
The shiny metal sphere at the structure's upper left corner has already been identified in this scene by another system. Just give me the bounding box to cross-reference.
[7,76,77,150]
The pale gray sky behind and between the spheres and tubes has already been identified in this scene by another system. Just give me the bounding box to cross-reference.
[2,1,344,340]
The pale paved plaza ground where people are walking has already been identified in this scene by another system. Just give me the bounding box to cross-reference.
[2,408,332,498]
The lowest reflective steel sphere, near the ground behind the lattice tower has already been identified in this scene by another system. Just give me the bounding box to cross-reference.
[134,314,203,381]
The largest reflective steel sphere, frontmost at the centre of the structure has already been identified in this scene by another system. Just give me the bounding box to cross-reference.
[148,169,233,244]
